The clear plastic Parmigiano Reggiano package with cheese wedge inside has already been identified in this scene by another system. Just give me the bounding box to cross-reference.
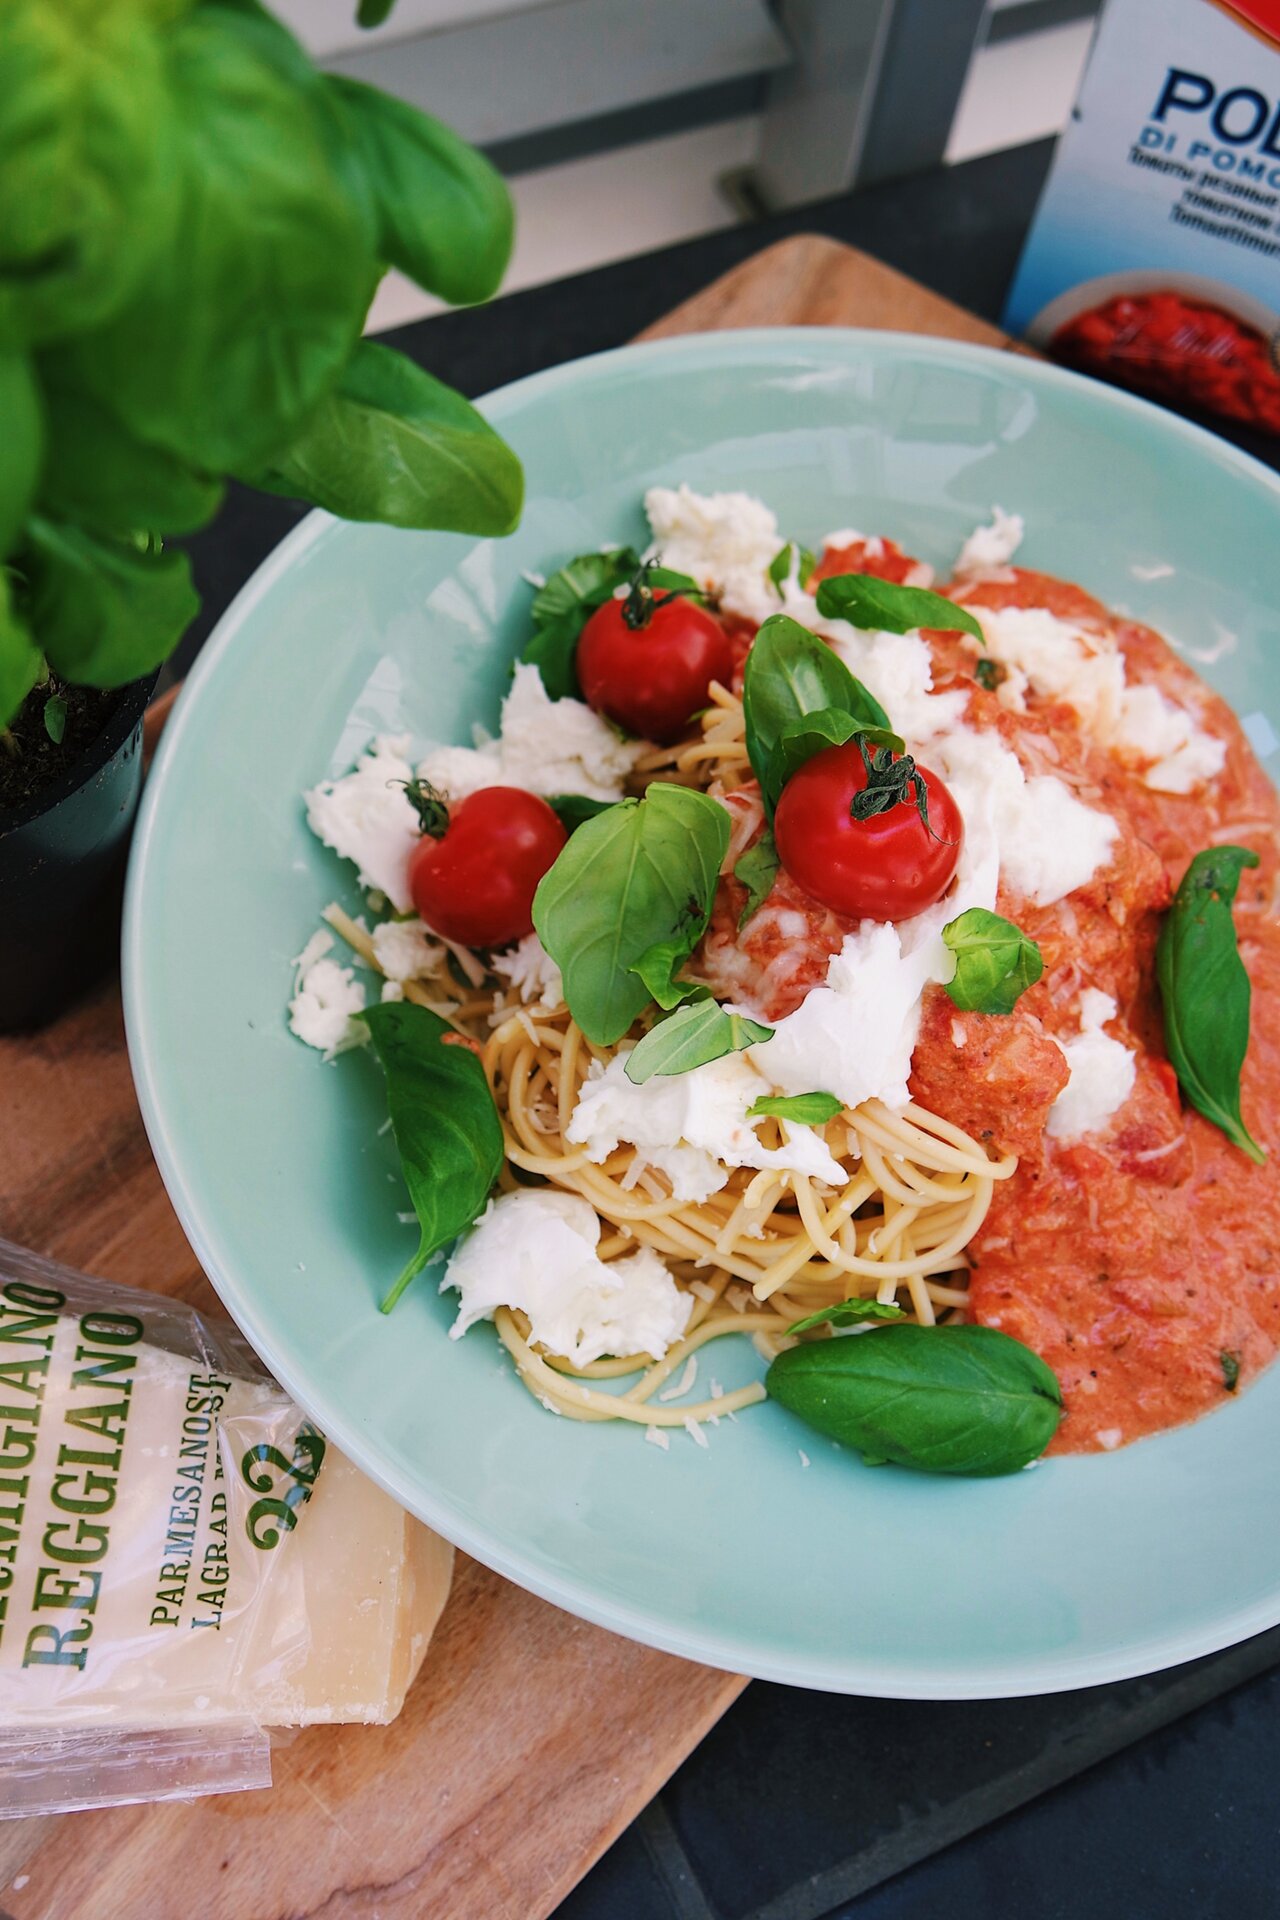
[0,1242,453,1812]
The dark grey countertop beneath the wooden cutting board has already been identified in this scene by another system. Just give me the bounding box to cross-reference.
[177,142,1280,1920]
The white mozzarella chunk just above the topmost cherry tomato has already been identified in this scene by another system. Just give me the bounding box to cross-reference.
[645,486,783,620]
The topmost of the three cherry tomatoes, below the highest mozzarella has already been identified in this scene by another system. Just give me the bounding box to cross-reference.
[578,588,735,743]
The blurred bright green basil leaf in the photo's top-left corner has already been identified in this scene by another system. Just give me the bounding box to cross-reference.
[0,0,175,346]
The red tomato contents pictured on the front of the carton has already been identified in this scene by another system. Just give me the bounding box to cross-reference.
[1052,292,1280,434]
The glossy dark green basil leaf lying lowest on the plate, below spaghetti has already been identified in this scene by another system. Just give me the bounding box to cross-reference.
[764,1323,1063,1475]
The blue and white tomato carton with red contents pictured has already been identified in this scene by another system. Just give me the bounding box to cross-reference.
[1004,0,1280,434]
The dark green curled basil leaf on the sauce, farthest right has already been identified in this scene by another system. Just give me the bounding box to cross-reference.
[1155,847,1265,1165]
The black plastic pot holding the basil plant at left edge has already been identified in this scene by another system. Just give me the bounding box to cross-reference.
[0,674,157,1033]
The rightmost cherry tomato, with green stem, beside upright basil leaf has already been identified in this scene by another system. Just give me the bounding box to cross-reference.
[773,739,963,920]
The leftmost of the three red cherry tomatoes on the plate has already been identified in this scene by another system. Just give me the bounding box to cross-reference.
[409,787,568,947]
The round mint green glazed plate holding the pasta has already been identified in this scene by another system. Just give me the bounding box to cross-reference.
[125,330,1280,1699]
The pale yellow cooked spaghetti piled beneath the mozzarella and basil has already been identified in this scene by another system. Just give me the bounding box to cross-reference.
[326,894,1017,1427]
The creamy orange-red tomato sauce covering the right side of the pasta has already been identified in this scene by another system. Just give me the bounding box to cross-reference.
[699,541,1280,1452]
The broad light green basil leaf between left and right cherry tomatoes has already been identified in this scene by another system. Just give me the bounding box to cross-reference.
[533,781,729,1046]
